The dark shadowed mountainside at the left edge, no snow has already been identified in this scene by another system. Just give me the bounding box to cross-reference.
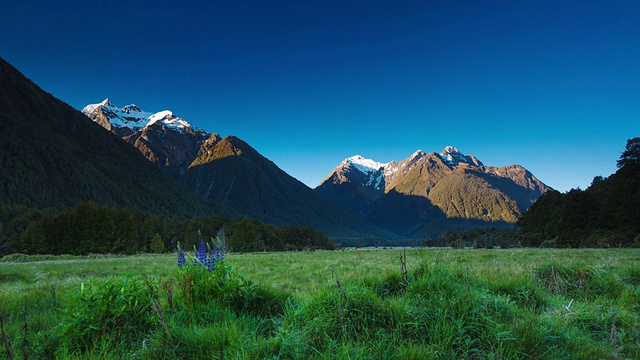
[0,58,231,216]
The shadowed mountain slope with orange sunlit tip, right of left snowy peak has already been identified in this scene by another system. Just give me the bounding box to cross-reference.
[183,136,392,237]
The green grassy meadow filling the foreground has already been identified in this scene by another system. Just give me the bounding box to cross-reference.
[0,249,640,359]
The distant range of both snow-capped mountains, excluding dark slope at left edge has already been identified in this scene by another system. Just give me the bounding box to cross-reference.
[82,99,549,238]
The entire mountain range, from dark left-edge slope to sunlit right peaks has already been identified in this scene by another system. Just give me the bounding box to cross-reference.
[0,54,548,243]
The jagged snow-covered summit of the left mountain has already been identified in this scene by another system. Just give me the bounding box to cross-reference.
[82,98,204,136]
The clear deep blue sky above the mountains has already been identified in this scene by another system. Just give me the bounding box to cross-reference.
[0,0,640,192]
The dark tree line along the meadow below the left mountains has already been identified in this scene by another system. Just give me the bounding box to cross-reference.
[0,202,334,256]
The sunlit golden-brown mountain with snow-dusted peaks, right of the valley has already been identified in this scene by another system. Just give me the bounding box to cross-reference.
[315,146,549,236]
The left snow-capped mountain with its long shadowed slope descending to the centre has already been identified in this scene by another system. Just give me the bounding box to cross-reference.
[82,99,394,238]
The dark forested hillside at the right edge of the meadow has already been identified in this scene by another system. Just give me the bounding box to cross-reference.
[517,137,640,247]
